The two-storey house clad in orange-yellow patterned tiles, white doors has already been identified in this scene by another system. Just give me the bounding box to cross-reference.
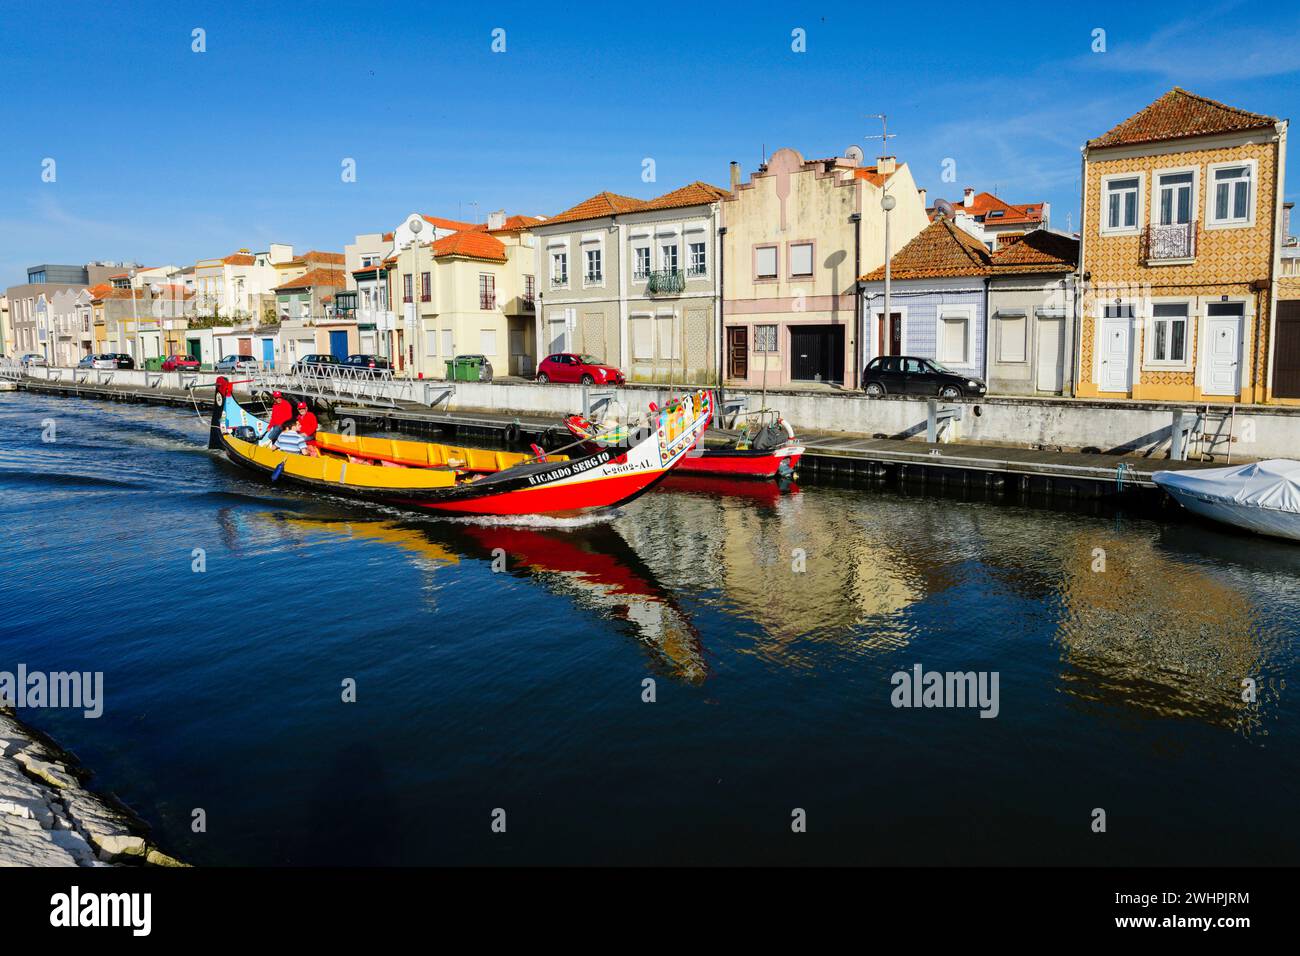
[1076,88,1300,403]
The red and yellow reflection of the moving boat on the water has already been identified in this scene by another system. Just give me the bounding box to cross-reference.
[249,514,709,683]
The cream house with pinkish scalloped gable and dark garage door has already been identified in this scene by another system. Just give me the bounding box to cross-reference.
[722,148,928,388]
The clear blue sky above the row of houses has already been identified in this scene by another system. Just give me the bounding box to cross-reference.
[0,0,1300,287]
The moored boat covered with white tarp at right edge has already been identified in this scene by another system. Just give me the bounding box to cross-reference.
[1151,458,1300,541]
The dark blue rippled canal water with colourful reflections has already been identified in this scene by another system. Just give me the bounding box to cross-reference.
[0,393,1300,865]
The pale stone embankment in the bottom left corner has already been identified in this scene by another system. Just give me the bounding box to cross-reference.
[0,708,183,866]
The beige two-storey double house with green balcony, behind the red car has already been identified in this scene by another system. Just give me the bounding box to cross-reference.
[533,182,727,384]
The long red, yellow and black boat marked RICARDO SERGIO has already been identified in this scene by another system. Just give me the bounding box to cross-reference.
[208,377,712,515]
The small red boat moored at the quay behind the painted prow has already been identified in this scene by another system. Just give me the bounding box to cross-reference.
[564,410,803,480]
